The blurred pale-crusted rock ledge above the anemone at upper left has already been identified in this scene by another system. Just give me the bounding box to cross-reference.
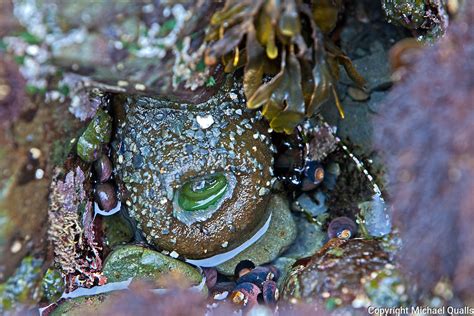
[9,0,219,101]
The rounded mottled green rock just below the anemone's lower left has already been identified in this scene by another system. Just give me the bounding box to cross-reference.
[103,246,202,285]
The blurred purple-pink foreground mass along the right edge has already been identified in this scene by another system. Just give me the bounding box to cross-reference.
[375,3,474,299]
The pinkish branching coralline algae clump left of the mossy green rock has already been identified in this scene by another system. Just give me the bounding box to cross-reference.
[48,167,106,290]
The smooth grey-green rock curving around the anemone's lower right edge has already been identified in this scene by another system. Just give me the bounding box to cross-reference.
[217,195,297,275]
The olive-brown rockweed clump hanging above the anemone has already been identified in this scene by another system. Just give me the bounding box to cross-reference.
[205,0,365,134]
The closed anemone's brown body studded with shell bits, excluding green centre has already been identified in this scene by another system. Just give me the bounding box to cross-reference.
[113,82,273,259]
